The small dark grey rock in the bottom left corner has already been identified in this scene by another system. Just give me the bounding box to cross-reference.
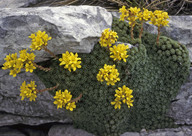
[0,127,26,136]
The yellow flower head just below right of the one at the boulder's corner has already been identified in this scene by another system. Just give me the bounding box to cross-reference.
[110,44,129,62]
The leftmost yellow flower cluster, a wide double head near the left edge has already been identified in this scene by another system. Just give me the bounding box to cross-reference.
[2,49,36,77]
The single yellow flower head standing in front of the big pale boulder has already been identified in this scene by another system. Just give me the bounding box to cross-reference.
[29,30,51,50]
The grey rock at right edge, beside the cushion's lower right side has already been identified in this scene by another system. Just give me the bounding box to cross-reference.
[168,68,192,125]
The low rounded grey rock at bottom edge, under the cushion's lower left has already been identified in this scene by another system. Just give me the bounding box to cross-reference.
[48,125,95,136]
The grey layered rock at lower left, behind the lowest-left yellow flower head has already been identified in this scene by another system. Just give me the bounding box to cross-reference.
[0,70,71,126]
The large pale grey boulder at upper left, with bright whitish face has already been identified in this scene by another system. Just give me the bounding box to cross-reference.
[0,6,112,65]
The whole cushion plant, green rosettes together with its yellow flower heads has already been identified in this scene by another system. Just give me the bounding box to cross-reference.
[3,6,190,136]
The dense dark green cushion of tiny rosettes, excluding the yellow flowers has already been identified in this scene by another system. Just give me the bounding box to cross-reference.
[36,19,190,136]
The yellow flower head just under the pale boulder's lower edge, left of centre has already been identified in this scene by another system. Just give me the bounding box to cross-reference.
[59,51,81,72]
